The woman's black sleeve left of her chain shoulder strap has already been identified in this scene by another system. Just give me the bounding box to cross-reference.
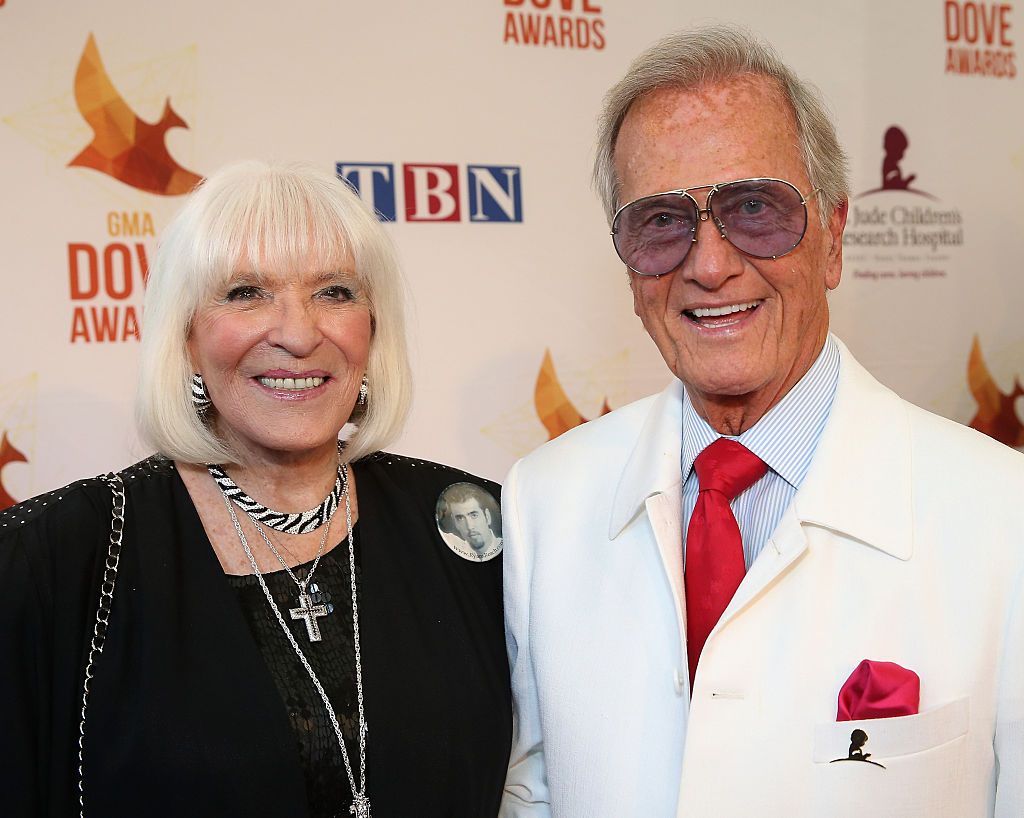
[0,480,110,818]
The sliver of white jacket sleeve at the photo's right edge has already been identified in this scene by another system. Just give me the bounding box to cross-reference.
[994,571,1024,818]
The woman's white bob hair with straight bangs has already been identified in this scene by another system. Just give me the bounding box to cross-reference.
[136,162,412,464]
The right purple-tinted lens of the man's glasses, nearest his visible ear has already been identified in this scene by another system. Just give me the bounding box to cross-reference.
[711,179,807,258]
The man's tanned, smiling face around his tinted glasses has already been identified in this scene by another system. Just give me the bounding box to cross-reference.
[615,77,846,433]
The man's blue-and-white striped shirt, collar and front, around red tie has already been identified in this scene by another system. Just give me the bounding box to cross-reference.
[681,335,840,568]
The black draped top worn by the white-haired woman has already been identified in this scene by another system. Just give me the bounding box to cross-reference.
[0,454,511,818]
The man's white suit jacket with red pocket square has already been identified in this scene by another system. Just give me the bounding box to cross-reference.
[501,347,1024,818]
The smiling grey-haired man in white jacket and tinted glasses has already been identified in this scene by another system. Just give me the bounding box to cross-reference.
[502,29,1024,818]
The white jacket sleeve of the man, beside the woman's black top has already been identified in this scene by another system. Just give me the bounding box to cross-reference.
[499,464,551,818]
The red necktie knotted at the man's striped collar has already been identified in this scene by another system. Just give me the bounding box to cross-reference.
[684,437,768,688]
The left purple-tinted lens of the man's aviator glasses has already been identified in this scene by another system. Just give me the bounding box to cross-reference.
[611,193,697,275]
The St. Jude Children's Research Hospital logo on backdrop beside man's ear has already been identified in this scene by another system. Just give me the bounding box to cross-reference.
[843,125,964,281]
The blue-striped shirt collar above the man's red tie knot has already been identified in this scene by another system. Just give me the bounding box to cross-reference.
[680,335,840,488]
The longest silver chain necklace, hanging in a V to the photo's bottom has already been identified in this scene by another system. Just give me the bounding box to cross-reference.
[224,464,370,818]
